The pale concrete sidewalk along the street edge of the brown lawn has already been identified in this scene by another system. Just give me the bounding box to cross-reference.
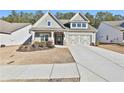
[0,63,79,82]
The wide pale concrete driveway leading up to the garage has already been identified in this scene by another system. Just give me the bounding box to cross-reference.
[69,46,124,82]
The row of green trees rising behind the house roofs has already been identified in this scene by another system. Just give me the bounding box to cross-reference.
[1,10,124,28]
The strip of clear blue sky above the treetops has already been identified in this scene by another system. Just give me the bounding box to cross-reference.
[0,10,124,18]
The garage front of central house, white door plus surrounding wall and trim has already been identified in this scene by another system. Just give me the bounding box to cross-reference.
[67,33,95,46]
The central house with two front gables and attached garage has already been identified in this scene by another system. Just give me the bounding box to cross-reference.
[31,12,96,45]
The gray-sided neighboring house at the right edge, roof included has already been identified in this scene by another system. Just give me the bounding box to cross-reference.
[97,21,124,43]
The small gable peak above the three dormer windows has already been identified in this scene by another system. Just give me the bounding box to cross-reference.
[69,13,90,22]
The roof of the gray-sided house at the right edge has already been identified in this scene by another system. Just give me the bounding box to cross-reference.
[102,20,124,31]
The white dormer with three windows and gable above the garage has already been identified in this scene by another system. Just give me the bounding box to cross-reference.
[69,13,89,29]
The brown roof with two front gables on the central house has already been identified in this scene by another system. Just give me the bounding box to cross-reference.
[30,12,96,32]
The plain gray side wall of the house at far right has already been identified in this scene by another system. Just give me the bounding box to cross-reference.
[97,23,123,43]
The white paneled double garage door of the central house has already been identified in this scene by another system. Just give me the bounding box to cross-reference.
[68,34,91,45]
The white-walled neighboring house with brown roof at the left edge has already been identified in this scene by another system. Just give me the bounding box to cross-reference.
[0,20,31,46]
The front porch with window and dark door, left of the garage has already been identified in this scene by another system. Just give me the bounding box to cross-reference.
[32,31,65,45]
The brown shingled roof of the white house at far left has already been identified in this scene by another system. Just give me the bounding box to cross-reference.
[0,20,30,34]
